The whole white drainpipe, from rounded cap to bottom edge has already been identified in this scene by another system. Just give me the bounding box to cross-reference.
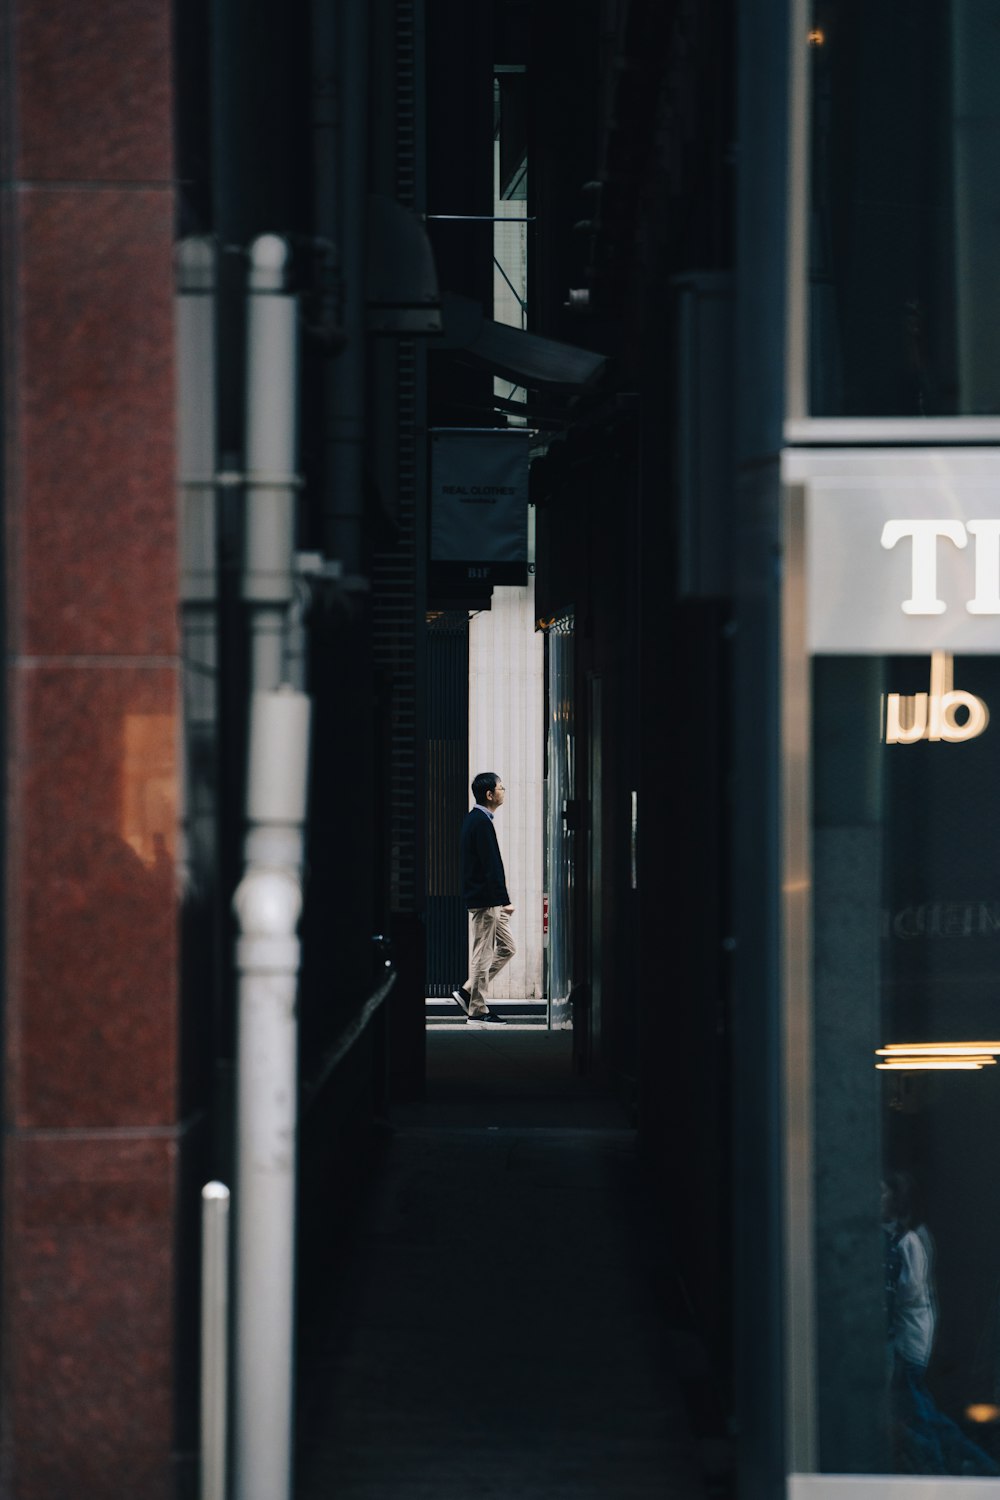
[234,234,309,1500]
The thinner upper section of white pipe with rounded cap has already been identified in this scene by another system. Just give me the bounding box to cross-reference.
[243,234,300,690]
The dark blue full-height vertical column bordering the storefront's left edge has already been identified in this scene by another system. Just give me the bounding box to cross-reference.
[727,0,791,1500]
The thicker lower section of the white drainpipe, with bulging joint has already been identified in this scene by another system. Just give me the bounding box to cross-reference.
[234,689,310,1500]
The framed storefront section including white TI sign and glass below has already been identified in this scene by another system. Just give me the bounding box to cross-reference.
[783,450,1000,1500]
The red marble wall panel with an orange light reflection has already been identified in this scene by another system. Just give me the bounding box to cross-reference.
[7,663,177,1128]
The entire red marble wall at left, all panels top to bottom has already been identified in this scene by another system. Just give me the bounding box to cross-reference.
[0,0,184,1500]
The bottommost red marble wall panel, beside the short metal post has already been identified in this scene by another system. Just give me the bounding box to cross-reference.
[4,1131,178,1500]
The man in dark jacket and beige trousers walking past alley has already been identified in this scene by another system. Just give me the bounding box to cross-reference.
[451,771,517,1026]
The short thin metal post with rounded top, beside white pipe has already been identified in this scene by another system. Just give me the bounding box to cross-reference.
[199,1182,229,1500]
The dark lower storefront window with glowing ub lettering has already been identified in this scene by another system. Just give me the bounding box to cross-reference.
[811,653,1000,1476]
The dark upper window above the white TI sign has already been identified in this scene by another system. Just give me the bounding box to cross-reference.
[808,0,1000,419]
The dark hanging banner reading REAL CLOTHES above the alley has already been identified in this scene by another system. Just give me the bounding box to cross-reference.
[430,428,531,588]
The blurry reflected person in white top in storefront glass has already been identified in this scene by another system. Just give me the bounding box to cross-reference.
[882,1172,1000,1476]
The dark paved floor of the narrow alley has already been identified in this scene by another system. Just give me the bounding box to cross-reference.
[297,1031,703,1500]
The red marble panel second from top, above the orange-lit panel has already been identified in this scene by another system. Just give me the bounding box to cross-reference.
[7,191,177,656]
